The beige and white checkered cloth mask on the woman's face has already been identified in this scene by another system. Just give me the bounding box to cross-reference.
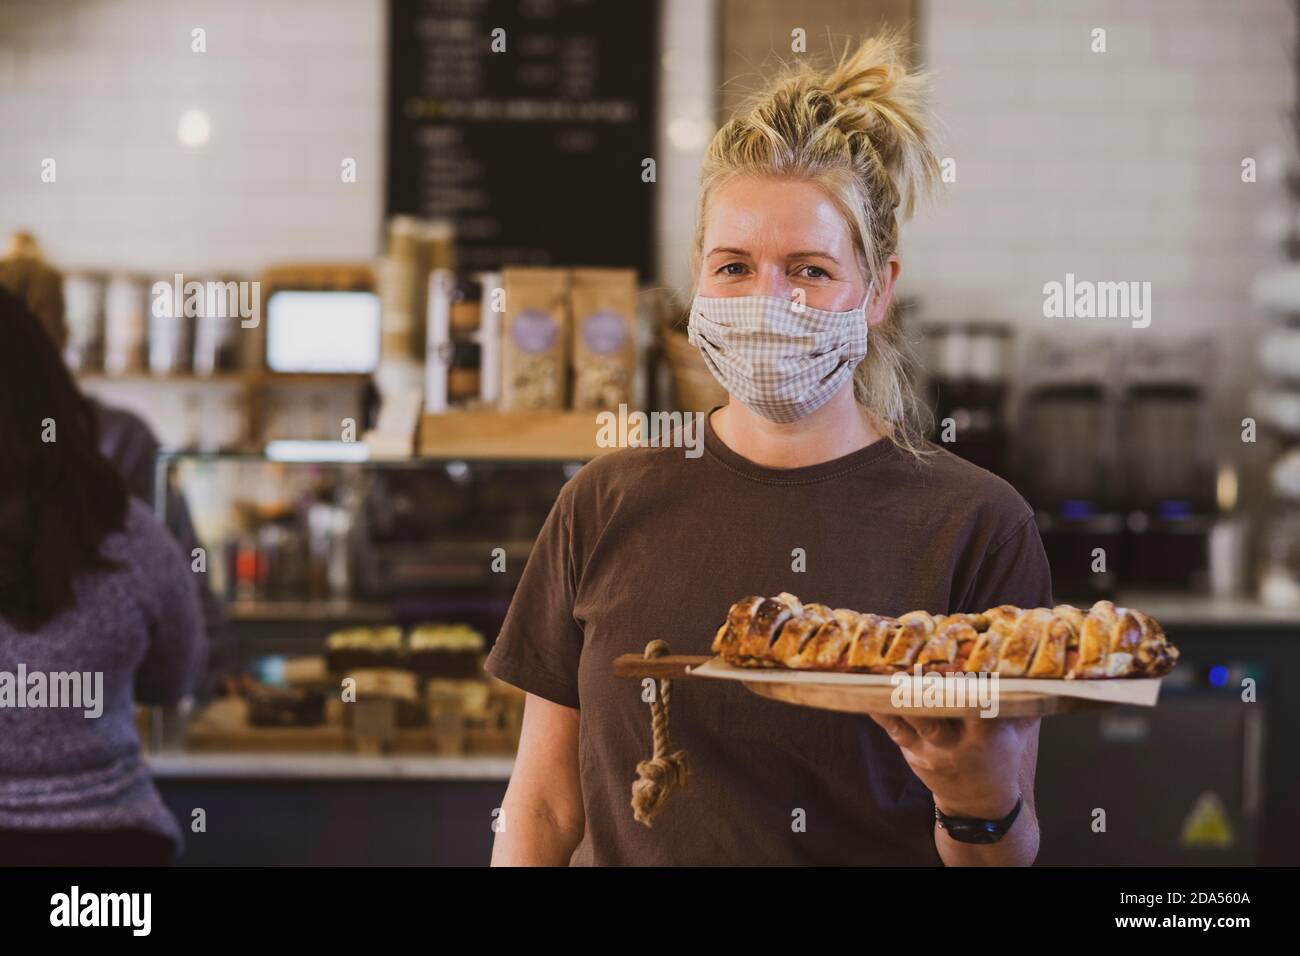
[686,287,871,421]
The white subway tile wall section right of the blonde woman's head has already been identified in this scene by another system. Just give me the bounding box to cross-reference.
[901,0,1296,336]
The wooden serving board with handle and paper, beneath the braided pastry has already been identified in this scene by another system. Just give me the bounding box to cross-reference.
[614,654,1160,718]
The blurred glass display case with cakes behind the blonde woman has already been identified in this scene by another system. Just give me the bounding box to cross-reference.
[146,449,581,757]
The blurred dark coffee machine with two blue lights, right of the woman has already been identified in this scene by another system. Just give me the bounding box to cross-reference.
[1015,338,1216,601]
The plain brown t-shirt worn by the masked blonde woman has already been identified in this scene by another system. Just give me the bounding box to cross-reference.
[488,413,1053,866]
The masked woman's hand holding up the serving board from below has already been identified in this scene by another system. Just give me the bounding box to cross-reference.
[871,714,1039,819]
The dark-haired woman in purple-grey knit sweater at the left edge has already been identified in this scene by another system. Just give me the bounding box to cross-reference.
[0,290,205,865]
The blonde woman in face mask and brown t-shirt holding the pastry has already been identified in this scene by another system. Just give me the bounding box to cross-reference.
[488,38,1052,865]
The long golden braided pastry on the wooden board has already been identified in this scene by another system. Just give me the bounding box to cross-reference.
[712,592,1178,680]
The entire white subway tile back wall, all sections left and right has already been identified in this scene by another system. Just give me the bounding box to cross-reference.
[0,0,1295,317]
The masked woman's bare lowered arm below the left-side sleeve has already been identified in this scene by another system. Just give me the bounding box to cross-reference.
[491,693,586,866]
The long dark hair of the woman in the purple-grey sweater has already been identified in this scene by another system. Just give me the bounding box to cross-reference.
[0,289,129,631]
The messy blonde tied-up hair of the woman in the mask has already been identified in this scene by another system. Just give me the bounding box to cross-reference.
[692,31,939,458]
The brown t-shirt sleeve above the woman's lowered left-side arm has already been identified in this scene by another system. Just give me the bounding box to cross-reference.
[485,481,582,708]
